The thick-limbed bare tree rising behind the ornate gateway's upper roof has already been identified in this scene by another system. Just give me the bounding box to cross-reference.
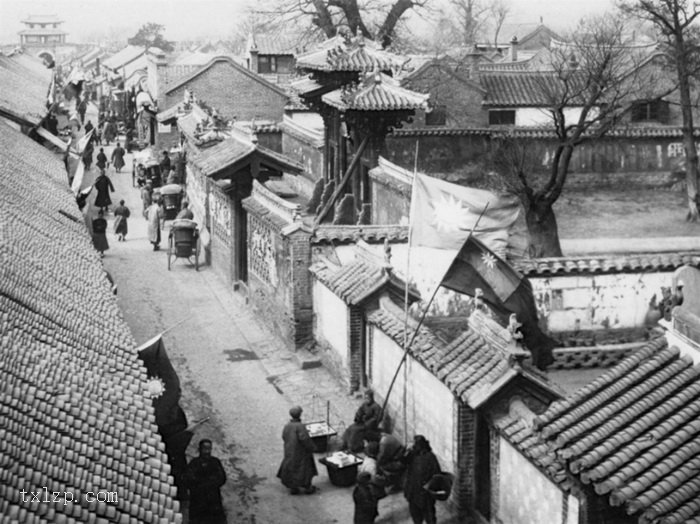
[252,0,430,47]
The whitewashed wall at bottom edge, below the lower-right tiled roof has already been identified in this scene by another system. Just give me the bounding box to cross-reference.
[497,439,578,524]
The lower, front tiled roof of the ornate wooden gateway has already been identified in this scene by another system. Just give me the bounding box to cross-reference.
[321,72,430,111]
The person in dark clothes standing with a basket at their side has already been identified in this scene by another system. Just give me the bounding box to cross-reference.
[404,435,440,524]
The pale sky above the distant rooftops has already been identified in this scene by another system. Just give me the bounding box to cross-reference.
[0,0,613,44]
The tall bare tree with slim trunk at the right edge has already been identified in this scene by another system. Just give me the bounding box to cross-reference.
[621,0,700,222]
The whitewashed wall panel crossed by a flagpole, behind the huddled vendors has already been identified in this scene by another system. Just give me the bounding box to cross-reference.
[370,325,457,473]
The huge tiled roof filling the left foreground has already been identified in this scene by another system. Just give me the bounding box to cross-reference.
[0,122,181,523]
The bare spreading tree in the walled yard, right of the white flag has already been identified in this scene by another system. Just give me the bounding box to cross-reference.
[494,17,675,257]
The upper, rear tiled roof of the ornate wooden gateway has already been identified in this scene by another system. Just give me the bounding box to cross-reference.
[297,37,408,72]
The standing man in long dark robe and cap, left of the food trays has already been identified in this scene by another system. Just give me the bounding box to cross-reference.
[277,406,318,495]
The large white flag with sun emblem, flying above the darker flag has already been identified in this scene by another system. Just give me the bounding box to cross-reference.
[410,173,521,256]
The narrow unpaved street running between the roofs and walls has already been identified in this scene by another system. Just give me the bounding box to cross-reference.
[83,119,457,524]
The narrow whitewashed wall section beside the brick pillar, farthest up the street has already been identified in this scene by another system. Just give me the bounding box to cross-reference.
[312,280,349,369]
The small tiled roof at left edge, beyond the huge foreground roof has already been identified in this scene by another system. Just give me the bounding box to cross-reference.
[0,56,50,125]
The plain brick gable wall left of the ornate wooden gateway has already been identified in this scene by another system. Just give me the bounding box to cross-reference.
[163,60,287,121]
